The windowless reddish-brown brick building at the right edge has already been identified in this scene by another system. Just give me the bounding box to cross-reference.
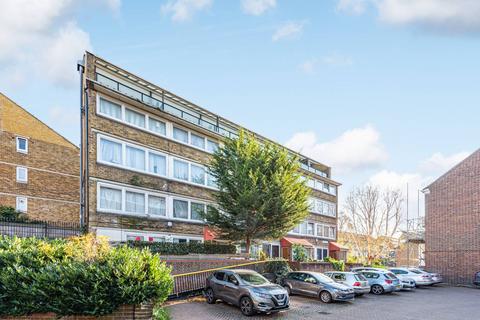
[424,150,480,284]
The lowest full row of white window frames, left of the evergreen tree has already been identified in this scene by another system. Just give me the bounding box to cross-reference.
[97,182,211,223]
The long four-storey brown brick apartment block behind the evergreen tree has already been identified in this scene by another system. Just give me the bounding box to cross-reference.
[80,53,339,259]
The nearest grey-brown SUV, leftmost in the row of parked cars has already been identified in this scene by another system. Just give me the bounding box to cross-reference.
[205,270,290,316]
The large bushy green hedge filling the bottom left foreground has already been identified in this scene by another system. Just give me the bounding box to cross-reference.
[0,235,173,317]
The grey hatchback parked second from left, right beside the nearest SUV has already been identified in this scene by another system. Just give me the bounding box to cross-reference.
[283,271,355,303]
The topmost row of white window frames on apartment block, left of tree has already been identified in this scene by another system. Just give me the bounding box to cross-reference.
[96,94,221,154]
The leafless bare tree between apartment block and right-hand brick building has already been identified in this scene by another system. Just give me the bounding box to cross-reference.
[339,185,403,264]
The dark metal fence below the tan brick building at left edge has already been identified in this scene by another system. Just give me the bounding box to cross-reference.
[0,218,82,239]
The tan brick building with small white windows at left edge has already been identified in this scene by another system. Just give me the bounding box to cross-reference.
[0,93,80,223]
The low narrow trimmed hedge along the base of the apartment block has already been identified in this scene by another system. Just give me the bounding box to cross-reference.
[128,241,237,255]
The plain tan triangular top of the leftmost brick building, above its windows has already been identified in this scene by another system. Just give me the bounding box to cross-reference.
[0,92,78,149]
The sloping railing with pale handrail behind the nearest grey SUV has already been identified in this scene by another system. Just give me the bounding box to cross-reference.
[170,260,278,297]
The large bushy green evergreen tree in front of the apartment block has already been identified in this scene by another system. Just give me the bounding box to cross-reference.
[205,132,309,253]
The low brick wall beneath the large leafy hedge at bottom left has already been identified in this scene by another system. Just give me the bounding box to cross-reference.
[0,303,153,320]
